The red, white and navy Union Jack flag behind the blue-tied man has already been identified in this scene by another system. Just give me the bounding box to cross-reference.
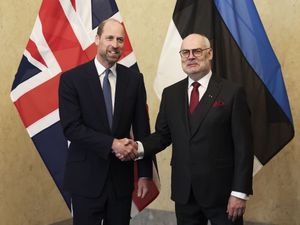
[11,0,160,217]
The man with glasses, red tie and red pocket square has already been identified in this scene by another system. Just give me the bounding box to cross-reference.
[120,34,253,225]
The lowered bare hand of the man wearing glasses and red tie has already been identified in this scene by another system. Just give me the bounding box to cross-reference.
[227,195,246,221]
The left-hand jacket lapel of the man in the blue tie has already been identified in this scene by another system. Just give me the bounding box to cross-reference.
[86,60,110,130]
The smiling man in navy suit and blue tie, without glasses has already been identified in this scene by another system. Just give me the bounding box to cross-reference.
[59,19,152,225]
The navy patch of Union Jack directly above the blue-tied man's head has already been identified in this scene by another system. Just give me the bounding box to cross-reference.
[92,0,118,29]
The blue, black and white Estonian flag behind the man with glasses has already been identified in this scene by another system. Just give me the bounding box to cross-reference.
[154,0,294,174]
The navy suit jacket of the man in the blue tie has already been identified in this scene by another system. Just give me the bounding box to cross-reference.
[59,60,152,197]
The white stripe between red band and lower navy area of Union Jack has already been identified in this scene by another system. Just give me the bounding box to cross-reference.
[26,109,59,137]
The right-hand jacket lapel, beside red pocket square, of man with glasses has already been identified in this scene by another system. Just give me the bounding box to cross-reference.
[190,76,221,137]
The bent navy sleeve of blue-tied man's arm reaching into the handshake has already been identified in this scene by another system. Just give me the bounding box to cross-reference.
[59,74,113,159]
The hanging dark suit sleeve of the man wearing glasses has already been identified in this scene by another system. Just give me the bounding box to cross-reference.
[231,88,254,195]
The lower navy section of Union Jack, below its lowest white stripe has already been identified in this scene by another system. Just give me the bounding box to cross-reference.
[32,122,71,207]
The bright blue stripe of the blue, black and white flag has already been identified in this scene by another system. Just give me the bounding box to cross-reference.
[214,0,293,122]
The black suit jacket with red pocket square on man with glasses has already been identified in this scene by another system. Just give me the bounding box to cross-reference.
[142,76,253,207]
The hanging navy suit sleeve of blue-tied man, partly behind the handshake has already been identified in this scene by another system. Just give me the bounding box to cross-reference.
[132,74,153,178]
